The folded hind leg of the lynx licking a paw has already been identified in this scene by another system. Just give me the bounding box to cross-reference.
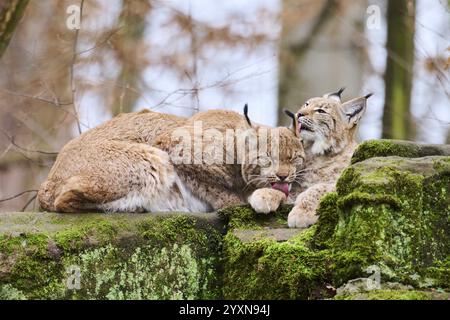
[49,141,181,212]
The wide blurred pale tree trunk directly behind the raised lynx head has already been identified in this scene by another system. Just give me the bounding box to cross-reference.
[278,0,367,125]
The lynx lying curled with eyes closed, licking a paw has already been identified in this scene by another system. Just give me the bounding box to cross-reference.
[38,110,304,212]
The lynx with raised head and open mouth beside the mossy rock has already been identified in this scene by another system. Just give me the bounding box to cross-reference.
[249,89,371,228]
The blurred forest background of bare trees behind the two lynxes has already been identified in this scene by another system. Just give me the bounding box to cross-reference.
[0,0,450,211]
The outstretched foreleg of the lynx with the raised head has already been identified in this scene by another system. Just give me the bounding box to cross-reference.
[288,183,335,228]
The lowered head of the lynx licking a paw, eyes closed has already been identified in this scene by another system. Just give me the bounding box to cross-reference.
[241,104,305,196]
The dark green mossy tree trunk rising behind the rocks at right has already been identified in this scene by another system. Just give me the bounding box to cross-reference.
[383,0,415,139]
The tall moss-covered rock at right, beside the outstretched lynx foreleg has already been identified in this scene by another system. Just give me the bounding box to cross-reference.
[328,156,450,288]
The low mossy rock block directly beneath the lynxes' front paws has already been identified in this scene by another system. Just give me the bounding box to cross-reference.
[220,206,329,299]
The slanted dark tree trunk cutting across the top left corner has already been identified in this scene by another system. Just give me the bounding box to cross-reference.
[0,0,28,58]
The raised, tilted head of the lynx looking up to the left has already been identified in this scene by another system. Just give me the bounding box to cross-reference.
[296,88,372,155]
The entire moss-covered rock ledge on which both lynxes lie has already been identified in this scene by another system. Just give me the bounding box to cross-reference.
[0,140,450,299]
